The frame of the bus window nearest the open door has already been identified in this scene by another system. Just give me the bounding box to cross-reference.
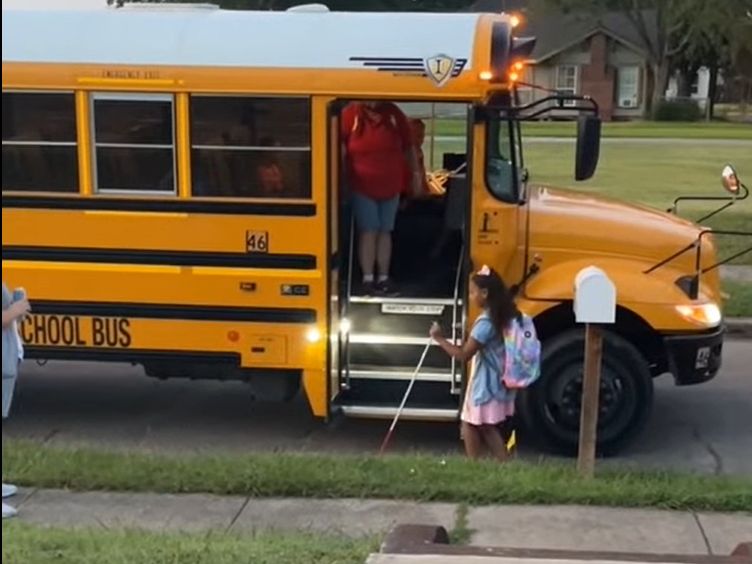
[187,96,315,204]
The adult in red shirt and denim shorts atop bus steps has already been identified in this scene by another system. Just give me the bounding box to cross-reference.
[341,102,423,294]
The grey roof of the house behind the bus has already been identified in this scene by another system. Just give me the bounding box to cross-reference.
[467,0,656,63]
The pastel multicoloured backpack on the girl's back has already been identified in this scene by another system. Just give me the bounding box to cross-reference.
[501,313,541,390]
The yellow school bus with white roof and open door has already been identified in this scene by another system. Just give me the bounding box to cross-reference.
[2,6,736,451]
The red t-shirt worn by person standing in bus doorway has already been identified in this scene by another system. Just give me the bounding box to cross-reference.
[341,103,412,200]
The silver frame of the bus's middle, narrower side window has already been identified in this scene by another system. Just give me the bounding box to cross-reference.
[89,92,178,198]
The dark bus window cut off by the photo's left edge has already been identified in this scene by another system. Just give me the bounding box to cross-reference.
[2,92,78,192]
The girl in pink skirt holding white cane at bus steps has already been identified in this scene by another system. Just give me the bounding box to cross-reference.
[430,266,520,461]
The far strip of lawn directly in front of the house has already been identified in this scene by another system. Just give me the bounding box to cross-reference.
[436,119,752,140]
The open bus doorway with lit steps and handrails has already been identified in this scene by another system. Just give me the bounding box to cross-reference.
[328,100,471,420]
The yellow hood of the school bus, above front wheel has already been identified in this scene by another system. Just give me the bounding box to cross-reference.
[528,186,715,274]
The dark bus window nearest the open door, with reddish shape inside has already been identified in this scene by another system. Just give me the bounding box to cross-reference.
[191,95,311,198]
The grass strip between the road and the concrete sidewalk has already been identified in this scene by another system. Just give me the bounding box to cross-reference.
[3,440,752,511]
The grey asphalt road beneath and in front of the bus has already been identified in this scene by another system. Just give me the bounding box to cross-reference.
[3,341,752,475]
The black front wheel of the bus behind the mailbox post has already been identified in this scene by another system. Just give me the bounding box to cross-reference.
[518,329,653,456]
